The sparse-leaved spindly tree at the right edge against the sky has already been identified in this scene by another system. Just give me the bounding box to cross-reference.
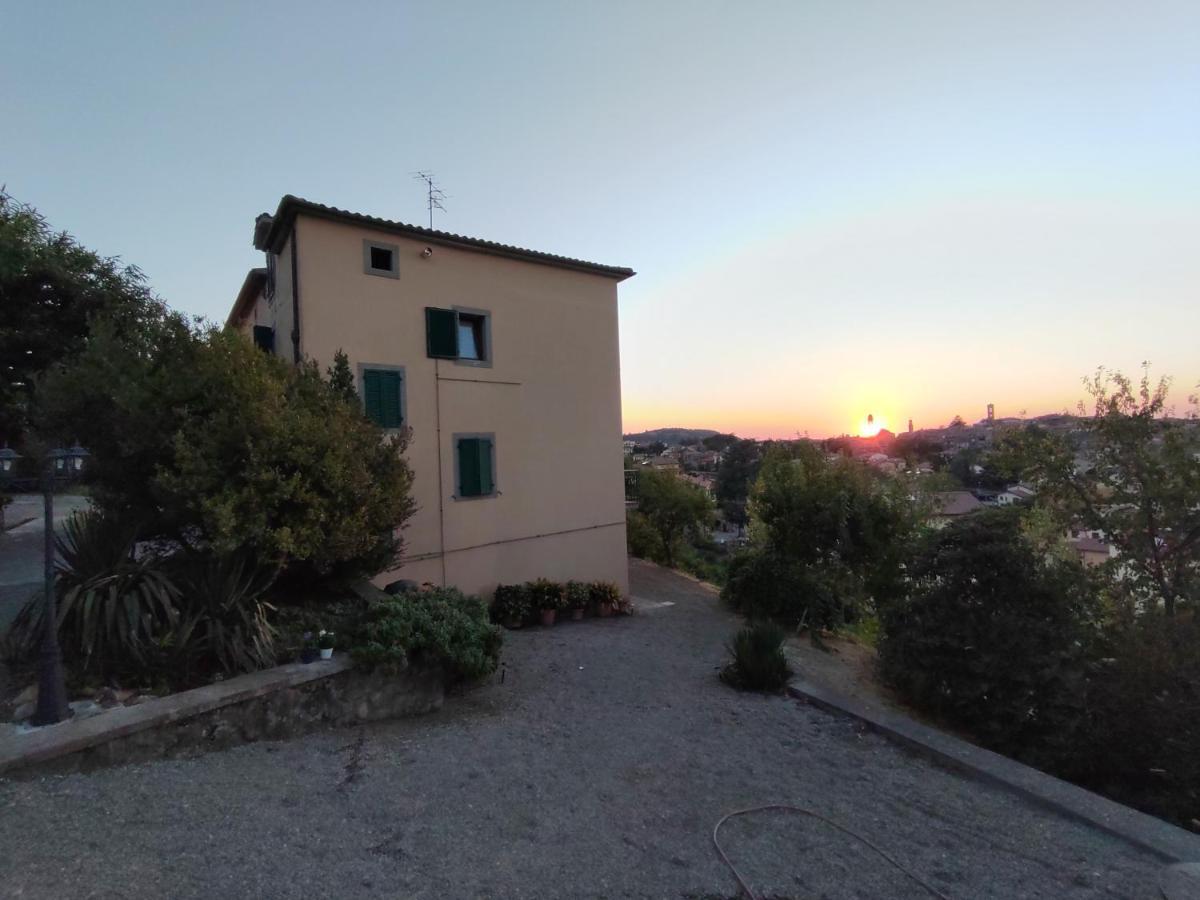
[1009,368,1200,617]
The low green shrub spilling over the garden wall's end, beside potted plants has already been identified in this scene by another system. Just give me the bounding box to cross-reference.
[352,588,503,682]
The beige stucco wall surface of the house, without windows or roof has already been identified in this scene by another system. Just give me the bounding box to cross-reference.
[291,217,629,602]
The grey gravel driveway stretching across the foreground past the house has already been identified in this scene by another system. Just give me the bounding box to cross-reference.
[0,563,1160,900]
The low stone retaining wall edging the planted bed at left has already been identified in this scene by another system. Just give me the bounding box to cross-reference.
[0,658,445,778]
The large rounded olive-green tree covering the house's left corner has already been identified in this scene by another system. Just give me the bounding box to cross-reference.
[42,313,413,585]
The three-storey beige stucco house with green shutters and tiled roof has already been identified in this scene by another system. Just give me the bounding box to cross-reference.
[228,196,634,596]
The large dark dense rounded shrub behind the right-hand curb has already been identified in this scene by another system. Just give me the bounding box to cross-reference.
[880,510,1096,766]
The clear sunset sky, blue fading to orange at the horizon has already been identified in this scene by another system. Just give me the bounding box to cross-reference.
[0,0,1200,436]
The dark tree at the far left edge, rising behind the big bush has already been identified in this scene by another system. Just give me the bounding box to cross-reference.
[0,190,162,443]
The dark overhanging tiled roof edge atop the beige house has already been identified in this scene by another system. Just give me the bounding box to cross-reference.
[254,194,635,281]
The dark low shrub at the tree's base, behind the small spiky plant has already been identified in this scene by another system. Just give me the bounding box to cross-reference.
[721,548,863,634]
